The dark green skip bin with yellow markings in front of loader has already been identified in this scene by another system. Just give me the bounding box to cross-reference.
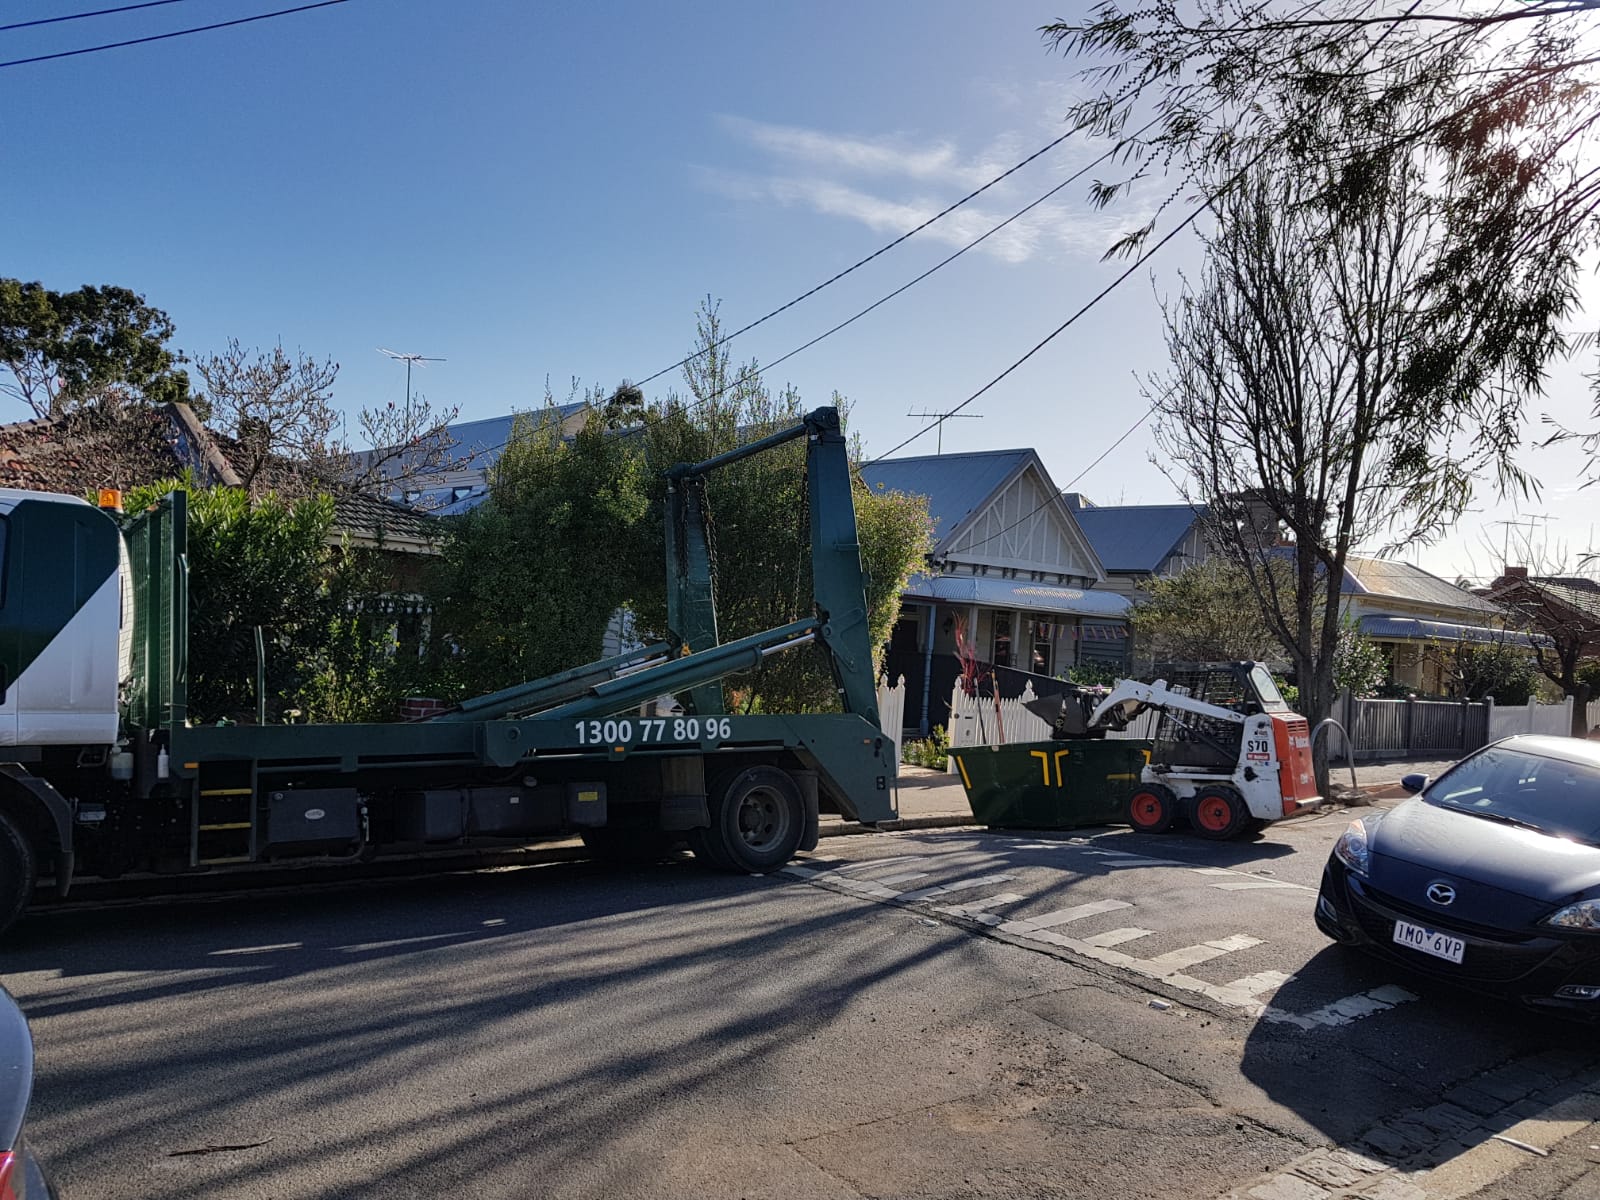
[950,739,1150,829]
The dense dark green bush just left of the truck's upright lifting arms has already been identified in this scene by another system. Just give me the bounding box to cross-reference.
[429,406,661,698]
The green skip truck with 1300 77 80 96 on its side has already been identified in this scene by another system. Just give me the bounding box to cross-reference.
[0,408,896,931]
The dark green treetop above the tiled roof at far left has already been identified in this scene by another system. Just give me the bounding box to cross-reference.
[0,278,189,418]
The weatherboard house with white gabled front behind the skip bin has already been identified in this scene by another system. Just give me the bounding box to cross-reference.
[861,450,1130,731]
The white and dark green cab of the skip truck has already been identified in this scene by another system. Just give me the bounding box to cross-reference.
[0,488,122,746]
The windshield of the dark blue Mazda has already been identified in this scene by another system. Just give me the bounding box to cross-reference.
[1422,746,1600,846]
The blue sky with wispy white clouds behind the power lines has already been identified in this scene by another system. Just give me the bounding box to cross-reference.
[0,0,1590,574]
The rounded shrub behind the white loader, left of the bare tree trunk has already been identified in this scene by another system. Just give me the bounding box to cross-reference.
[1130,557,1286,662]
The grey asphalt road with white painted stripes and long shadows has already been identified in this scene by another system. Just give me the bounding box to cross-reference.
[0,814,1600,1200]
